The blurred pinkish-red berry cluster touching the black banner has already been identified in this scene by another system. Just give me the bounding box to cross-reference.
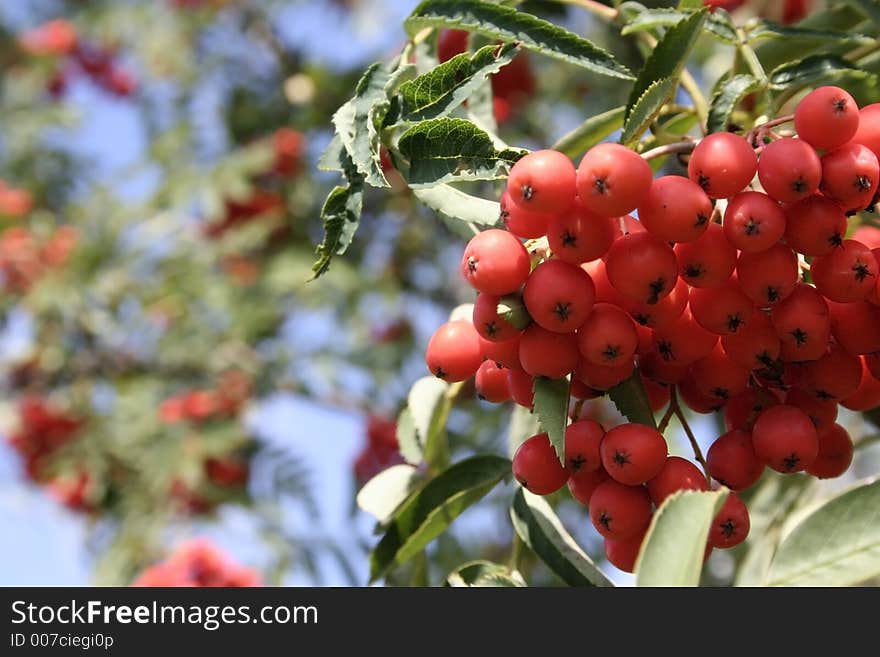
[132,539,260,587]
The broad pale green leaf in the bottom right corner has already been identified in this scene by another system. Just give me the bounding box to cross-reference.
[768,481,880,586]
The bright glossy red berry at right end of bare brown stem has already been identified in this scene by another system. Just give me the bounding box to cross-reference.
[688,132,758,198]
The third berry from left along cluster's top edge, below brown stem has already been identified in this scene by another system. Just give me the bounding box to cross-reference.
[639,176,712,242]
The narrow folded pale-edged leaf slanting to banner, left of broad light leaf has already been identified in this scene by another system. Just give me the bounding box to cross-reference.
[510,488,614,586]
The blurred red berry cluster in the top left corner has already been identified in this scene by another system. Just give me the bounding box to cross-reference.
[18,18,137,98]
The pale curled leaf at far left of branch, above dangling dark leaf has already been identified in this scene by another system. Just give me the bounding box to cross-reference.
[333,62,391,187]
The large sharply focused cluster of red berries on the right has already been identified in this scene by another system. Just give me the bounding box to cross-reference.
[426,87,880,565]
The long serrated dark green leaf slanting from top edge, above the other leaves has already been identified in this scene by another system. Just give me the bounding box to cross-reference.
[405,0,632,80]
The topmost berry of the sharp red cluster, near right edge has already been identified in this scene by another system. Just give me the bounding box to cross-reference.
[794,86,859,150]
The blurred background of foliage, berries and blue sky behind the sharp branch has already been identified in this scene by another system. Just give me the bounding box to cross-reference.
[0,0,877,584]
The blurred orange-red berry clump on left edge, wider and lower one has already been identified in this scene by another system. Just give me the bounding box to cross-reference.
[0,225,79,293]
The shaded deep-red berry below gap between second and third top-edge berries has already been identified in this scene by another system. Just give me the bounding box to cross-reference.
[605,233,678,305]
